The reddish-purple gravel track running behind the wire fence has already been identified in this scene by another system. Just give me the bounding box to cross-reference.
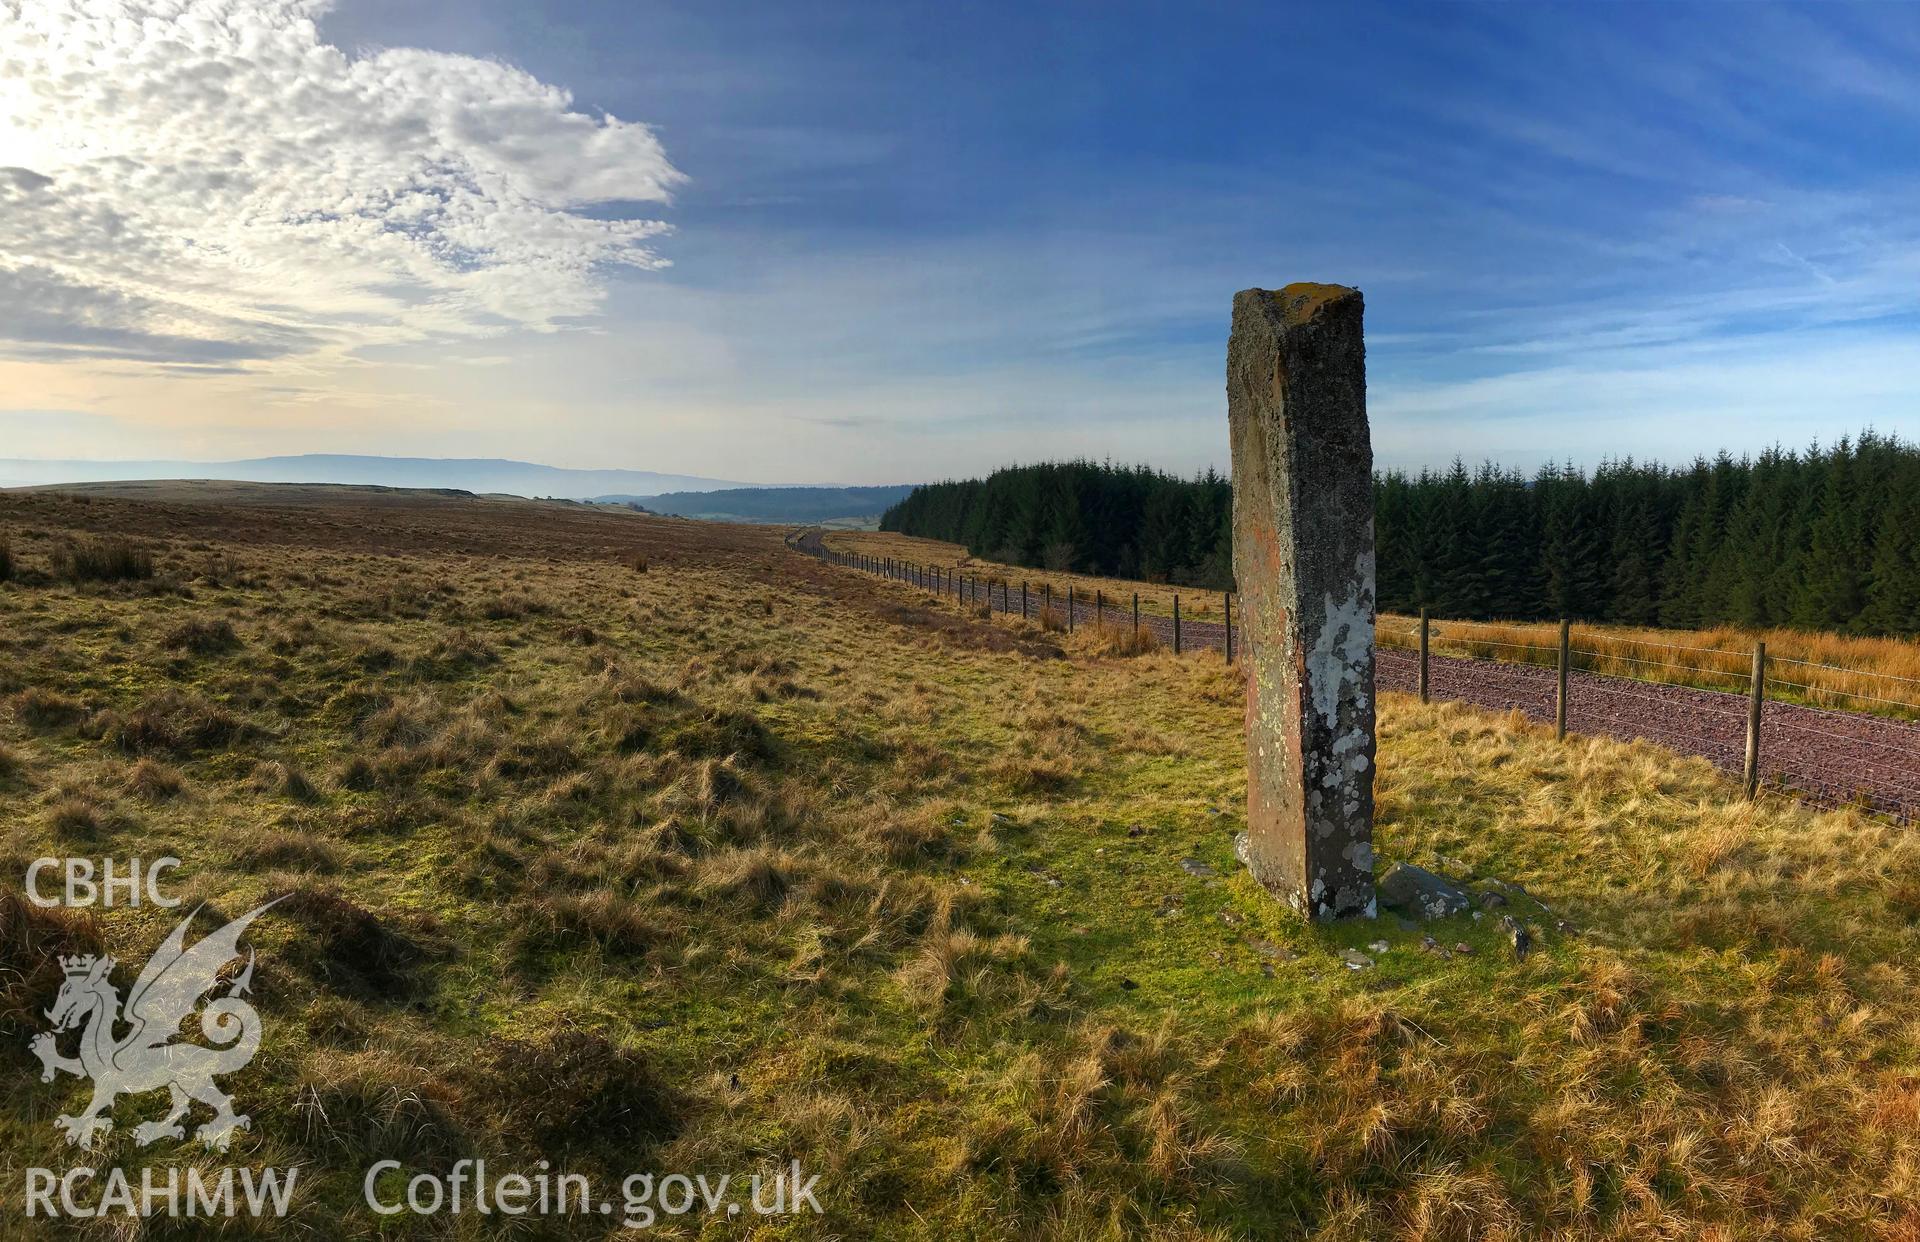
[801,537,1920,822]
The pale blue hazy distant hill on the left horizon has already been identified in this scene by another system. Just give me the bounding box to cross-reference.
[0,453,748,499]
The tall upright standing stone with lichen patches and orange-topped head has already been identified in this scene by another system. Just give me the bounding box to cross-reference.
[1227,284,1375,918]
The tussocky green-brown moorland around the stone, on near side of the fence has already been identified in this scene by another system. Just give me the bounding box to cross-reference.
[0,490,1920,1238]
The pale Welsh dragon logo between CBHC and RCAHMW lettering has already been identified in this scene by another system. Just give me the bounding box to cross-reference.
[27,898,284,1152]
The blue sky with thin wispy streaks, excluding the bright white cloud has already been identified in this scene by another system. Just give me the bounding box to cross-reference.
[0,0,1920,482]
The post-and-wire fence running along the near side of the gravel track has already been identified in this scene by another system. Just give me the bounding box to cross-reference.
[787,532,1920,822]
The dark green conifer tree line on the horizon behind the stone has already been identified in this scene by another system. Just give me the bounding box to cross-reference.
[881,432,1920,633]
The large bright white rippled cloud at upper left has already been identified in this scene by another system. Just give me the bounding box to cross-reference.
[0,0,682,367]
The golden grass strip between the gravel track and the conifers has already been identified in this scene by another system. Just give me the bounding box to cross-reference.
[826,532,1920,718]
